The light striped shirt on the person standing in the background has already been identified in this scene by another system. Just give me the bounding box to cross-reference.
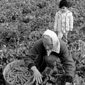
[54,10,73,33]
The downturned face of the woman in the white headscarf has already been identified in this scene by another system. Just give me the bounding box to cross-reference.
[43,36,53,51]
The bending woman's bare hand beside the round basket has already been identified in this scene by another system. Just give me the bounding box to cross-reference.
[31,66,42,85]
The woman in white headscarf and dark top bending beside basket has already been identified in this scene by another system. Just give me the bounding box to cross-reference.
[3,29,75,85]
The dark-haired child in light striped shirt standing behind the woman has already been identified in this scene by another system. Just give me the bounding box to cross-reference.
[54,0,73,42]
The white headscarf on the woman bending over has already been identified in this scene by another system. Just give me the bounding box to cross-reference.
[43,29,60,54]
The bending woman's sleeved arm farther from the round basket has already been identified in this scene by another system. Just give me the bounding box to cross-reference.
[61,41,75,82]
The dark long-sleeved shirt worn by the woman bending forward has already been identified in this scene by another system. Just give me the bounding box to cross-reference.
[24,39,75,77]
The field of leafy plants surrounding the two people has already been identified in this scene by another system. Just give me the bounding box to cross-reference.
[0,0,85,85]
